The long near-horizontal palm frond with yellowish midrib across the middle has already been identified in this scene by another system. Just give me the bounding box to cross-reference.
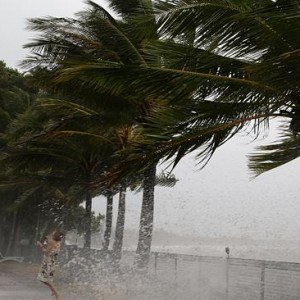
[47,62,281,107]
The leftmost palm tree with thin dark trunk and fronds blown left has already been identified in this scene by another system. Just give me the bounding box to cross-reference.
[2,126,114,248]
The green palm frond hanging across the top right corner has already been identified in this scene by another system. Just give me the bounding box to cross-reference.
[155,0,299,57]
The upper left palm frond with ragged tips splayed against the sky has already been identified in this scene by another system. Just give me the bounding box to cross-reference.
[25,2,144,67]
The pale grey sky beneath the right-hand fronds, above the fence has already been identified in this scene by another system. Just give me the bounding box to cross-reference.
[101,126,300,240]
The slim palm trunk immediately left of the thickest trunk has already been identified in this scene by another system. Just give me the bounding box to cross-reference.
[113,184,126,259]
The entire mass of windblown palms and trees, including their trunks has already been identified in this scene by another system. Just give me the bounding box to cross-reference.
[0,0,300,267]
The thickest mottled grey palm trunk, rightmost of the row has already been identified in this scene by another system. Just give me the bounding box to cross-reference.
[135,164,156,268]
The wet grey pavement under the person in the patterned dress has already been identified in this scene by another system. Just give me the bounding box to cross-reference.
[0,262,88,300]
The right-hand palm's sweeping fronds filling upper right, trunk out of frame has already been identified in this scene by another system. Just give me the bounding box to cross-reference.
[123,0,300,169]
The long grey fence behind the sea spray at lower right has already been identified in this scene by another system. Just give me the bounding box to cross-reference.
[62,250,300,300]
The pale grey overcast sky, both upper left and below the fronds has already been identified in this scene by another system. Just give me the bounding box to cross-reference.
[0,0,300,244]
